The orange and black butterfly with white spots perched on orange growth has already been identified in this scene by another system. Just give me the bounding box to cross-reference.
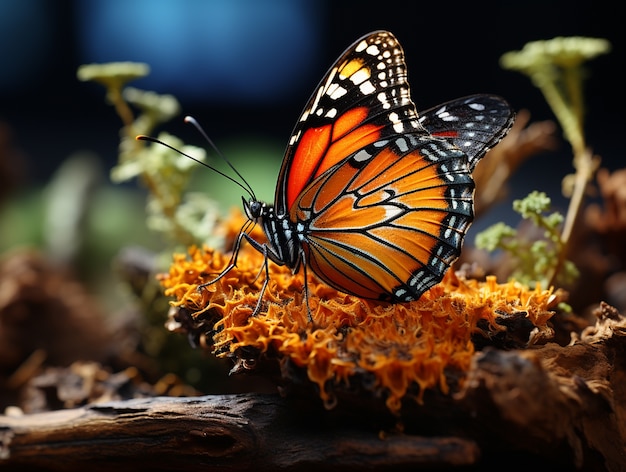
[141,31,514,320]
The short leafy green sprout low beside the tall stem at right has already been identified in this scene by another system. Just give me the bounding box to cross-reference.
[476,191,578,287]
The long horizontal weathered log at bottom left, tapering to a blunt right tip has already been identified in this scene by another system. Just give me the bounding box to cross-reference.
[0,395,478,471]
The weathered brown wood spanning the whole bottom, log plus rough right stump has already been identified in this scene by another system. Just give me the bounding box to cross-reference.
[0,305,626,472]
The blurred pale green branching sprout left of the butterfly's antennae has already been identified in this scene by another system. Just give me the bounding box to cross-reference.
[77,62,219,246]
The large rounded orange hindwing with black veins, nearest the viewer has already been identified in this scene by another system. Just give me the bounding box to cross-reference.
[291,134,474,302]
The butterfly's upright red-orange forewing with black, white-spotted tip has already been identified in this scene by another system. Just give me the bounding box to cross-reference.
[274,31,421,214]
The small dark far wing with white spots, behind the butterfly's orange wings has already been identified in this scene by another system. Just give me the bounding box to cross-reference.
[419,94,515,170]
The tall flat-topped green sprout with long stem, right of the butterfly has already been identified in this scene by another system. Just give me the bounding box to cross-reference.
[500,37,611,288]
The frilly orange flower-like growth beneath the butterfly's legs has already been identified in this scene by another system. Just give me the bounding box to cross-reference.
[161,210,556,412]
